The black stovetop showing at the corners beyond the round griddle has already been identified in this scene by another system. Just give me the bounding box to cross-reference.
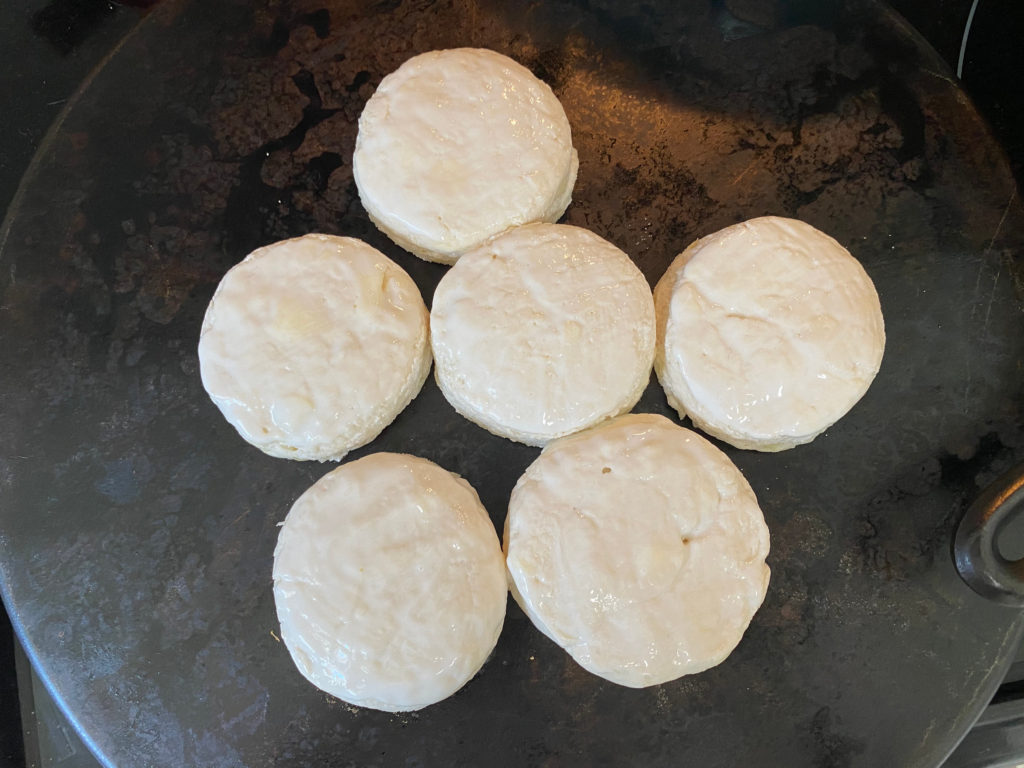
[0,0,1024,768]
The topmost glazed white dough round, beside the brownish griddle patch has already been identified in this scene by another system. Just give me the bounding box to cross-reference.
[352,48,580,264]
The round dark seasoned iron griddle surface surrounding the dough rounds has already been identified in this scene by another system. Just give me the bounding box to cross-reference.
[0,0,1024,768]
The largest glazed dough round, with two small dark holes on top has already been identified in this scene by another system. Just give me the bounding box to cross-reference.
[505,414,769,688]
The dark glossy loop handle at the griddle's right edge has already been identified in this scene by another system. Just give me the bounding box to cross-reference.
[953,465,1024,607]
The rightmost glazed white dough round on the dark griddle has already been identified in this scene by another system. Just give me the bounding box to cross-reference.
[654,216,886,451]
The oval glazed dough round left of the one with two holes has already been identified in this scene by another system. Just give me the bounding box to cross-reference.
[273,454,508,712]
